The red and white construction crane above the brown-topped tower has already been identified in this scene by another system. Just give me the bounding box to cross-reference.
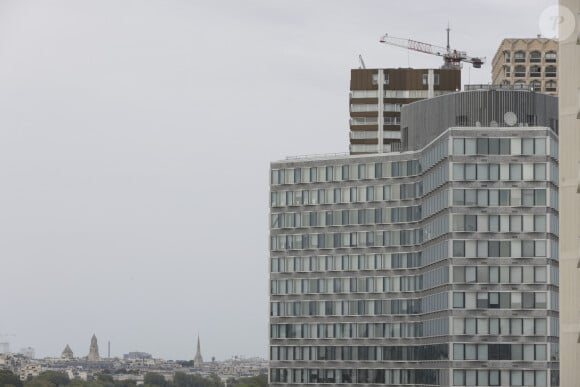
[381,27,485,69]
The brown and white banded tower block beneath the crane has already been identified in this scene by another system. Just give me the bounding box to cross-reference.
[349,68,461,154]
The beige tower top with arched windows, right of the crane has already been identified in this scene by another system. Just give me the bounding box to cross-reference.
[491,38,559,95]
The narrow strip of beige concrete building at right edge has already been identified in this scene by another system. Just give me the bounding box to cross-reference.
[559,0,580,386]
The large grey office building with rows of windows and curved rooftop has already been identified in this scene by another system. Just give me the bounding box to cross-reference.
[270,90,558,386]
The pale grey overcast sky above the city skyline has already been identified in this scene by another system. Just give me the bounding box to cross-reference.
[0,0,557,359]
